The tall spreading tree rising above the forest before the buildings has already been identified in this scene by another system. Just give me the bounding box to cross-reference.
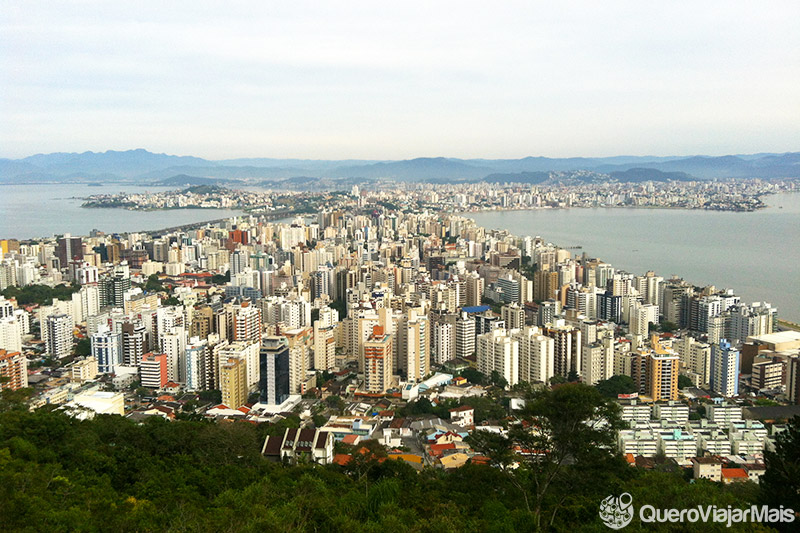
[470,383,622,529]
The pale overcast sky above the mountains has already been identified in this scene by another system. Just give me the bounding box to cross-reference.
[0,0,800,159]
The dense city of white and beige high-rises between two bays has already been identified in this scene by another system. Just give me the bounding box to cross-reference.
[0,175,800,528]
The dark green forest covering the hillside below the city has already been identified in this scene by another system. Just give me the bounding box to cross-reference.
[0,382,800,533]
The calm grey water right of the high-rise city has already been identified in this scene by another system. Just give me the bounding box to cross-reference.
[466,193,800,322]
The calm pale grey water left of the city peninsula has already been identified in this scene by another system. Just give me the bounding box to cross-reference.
[0,184,242,239]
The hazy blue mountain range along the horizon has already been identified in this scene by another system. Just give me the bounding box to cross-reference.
[0,149,800,188]
